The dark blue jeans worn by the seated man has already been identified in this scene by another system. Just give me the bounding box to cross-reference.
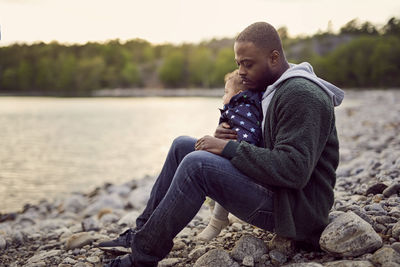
[132,136,274,266]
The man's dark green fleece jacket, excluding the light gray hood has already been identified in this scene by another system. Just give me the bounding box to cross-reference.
[222,77,339,247]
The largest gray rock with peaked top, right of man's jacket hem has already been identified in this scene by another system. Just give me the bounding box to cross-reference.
[320,211,382,256]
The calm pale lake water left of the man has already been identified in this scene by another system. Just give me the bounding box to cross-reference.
[0,97,222,212]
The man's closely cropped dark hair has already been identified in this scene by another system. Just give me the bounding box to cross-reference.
[235,22,283,54]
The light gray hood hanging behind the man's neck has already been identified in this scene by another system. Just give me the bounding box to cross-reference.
[263,62,344,106]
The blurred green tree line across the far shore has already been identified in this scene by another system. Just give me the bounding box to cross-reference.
[0,18,400,96]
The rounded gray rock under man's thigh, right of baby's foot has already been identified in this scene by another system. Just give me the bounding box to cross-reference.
[231,235,267,262]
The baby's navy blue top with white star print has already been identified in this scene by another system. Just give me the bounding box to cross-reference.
[219,90,264,147]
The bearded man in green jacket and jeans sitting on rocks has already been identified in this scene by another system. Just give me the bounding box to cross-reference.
[100,22,343,266]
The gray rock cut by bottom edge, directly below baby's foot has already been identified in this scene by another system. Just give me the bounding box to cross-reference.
[193,249,240,267]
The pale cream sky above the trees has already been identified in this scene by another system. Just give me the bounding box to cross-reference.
[0,0,400,46]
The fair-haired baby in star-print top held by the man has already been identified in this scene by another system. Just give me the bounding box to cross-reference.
[197,70,264,241]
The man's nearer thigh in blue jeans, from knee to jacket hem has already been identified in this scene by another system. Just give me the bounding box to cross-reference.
[187,151,274,231]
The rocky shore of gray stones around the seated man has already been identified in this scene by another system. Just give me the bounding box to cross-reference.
[0,90,400,267]
